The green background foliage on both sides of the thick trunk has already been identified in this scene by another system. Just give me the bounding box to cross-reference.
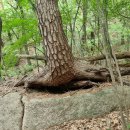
[0,0,130,77]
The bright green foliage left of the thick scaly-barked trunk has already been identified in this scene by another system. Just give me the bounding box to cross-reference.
[0,0,41,68]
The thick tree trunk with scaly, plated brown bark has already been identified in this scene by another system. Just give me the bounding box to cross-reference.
[37,0,74,86]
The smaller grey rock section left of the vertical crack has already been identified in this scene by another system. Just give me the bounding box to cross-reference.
[0,93,23,130]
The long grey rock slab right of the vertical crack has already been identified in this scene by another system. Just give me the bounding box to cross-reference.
[22,87,130,130]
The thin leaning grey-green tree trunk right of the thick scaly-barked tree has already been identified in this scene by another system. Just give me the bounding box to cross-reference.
[97,0,128,130]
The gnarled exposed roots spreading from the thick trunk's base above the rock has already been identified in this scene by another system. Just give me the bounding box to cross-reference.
[15,61,130,89]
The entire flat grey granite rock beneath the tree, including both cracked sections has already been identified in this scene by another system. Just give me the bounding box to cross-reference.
[0,87,130,130]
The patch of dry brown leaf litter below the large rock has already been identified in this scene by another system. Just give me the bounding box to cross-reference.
[47,111,130,130]
